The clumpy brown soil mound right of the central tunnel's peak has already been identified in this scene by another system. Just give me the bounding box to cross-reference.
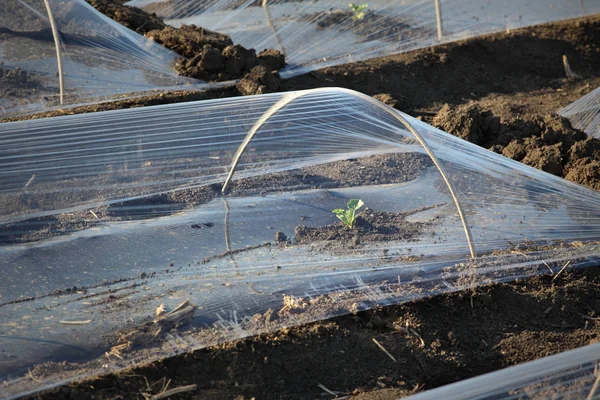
[432,103,600,190]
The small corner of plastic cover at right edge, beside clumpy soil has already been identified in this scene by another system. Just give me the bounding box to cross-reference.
[558,87,600,138]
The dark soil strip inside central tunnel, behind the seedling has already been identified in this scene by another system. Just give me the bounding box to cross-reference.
[0,153,433,244]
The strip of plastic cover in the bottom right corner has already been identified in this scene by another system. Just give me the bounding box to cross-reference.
[407,343,600,400]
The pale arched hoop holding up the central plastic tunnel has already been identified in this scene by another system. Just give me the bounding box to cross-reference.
[221,88,477,258]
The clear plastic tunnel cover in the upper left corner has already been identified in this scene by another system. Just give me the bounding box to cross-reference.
[0,0,203,116]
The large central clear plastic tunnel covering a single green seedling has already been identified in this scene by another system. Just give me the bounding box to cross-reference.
[0,89,600,397]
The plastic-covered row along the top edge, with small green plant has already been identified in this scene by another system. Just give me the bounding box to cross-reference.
[127,0,600,77]
